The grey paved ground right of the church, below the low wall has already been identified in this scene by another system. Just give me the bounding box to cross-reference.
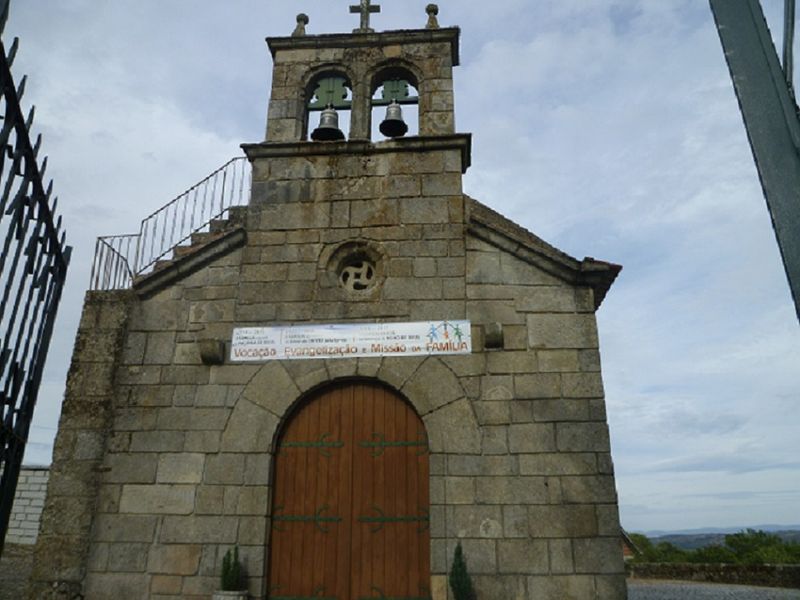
[628,581,800,600]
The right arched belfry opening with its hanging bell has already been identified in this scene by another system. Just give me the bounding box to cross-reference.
[371,67,419,140]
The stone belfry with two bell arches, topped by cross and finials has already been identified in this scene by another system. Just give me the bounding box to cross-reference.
[266,4,460,144]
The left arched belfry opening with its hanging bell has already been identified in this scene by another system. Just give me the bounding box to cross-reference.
[303,71,353,142]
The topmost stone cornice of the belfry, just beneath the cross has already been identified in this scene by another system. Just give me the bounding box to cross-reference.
[267,27,461,67]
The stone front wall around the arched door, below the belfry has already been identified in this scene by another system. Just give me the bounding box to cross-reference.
[40,143,625,600]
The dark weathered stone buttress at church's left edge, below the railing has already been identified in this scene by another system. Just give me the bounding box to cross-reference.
[29,292,131,600]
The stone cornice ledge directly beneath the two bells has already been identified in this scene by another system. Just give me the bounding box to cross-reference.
[242,133,472,173]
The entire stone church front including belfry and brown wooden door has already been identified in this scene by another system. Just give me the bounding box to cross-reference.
[30,8,626,600]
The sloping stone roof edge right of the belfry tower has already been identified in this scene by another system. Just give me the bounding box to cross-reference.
[465,196,622,310]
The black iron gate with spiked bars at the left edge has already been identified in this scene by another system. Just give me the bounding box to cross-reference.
[0,0,72,554]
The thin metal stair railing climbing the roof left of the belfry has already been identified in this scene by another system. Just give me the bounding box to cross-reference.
[90,156,251,290]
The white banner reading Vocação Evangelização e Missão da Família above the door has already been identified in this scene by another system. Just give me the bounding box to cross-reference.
[231,321,472,362]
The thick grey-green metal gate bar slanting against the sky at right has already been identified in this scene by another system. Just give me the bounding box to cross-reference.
[710,0,800,319]
